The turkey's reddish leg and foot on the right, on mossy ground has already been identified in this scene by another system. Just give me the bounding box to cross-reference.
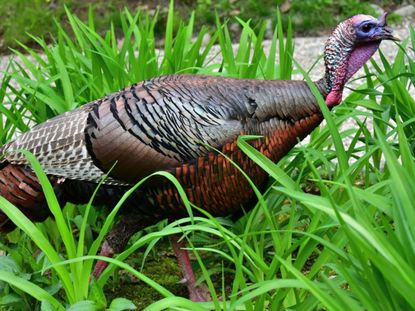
[169,234,212,301]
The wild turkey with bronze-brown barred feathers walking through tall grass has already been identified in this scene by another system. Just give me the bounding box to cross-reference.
[0,14,395,300]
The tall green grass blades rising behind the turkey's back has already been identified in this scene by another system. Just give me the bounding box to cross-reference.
[5,2,293,122]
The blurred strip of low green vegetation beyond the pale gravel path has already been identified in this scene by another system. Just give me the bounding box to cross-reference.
[0,0,402,53]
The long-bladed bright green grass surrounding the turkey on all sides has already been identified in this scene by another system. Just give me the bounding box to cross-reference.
[0,4,415,311]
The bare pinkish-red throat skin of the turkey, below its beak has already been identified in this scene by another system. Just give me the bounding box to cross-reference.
[326,41,380,108]
